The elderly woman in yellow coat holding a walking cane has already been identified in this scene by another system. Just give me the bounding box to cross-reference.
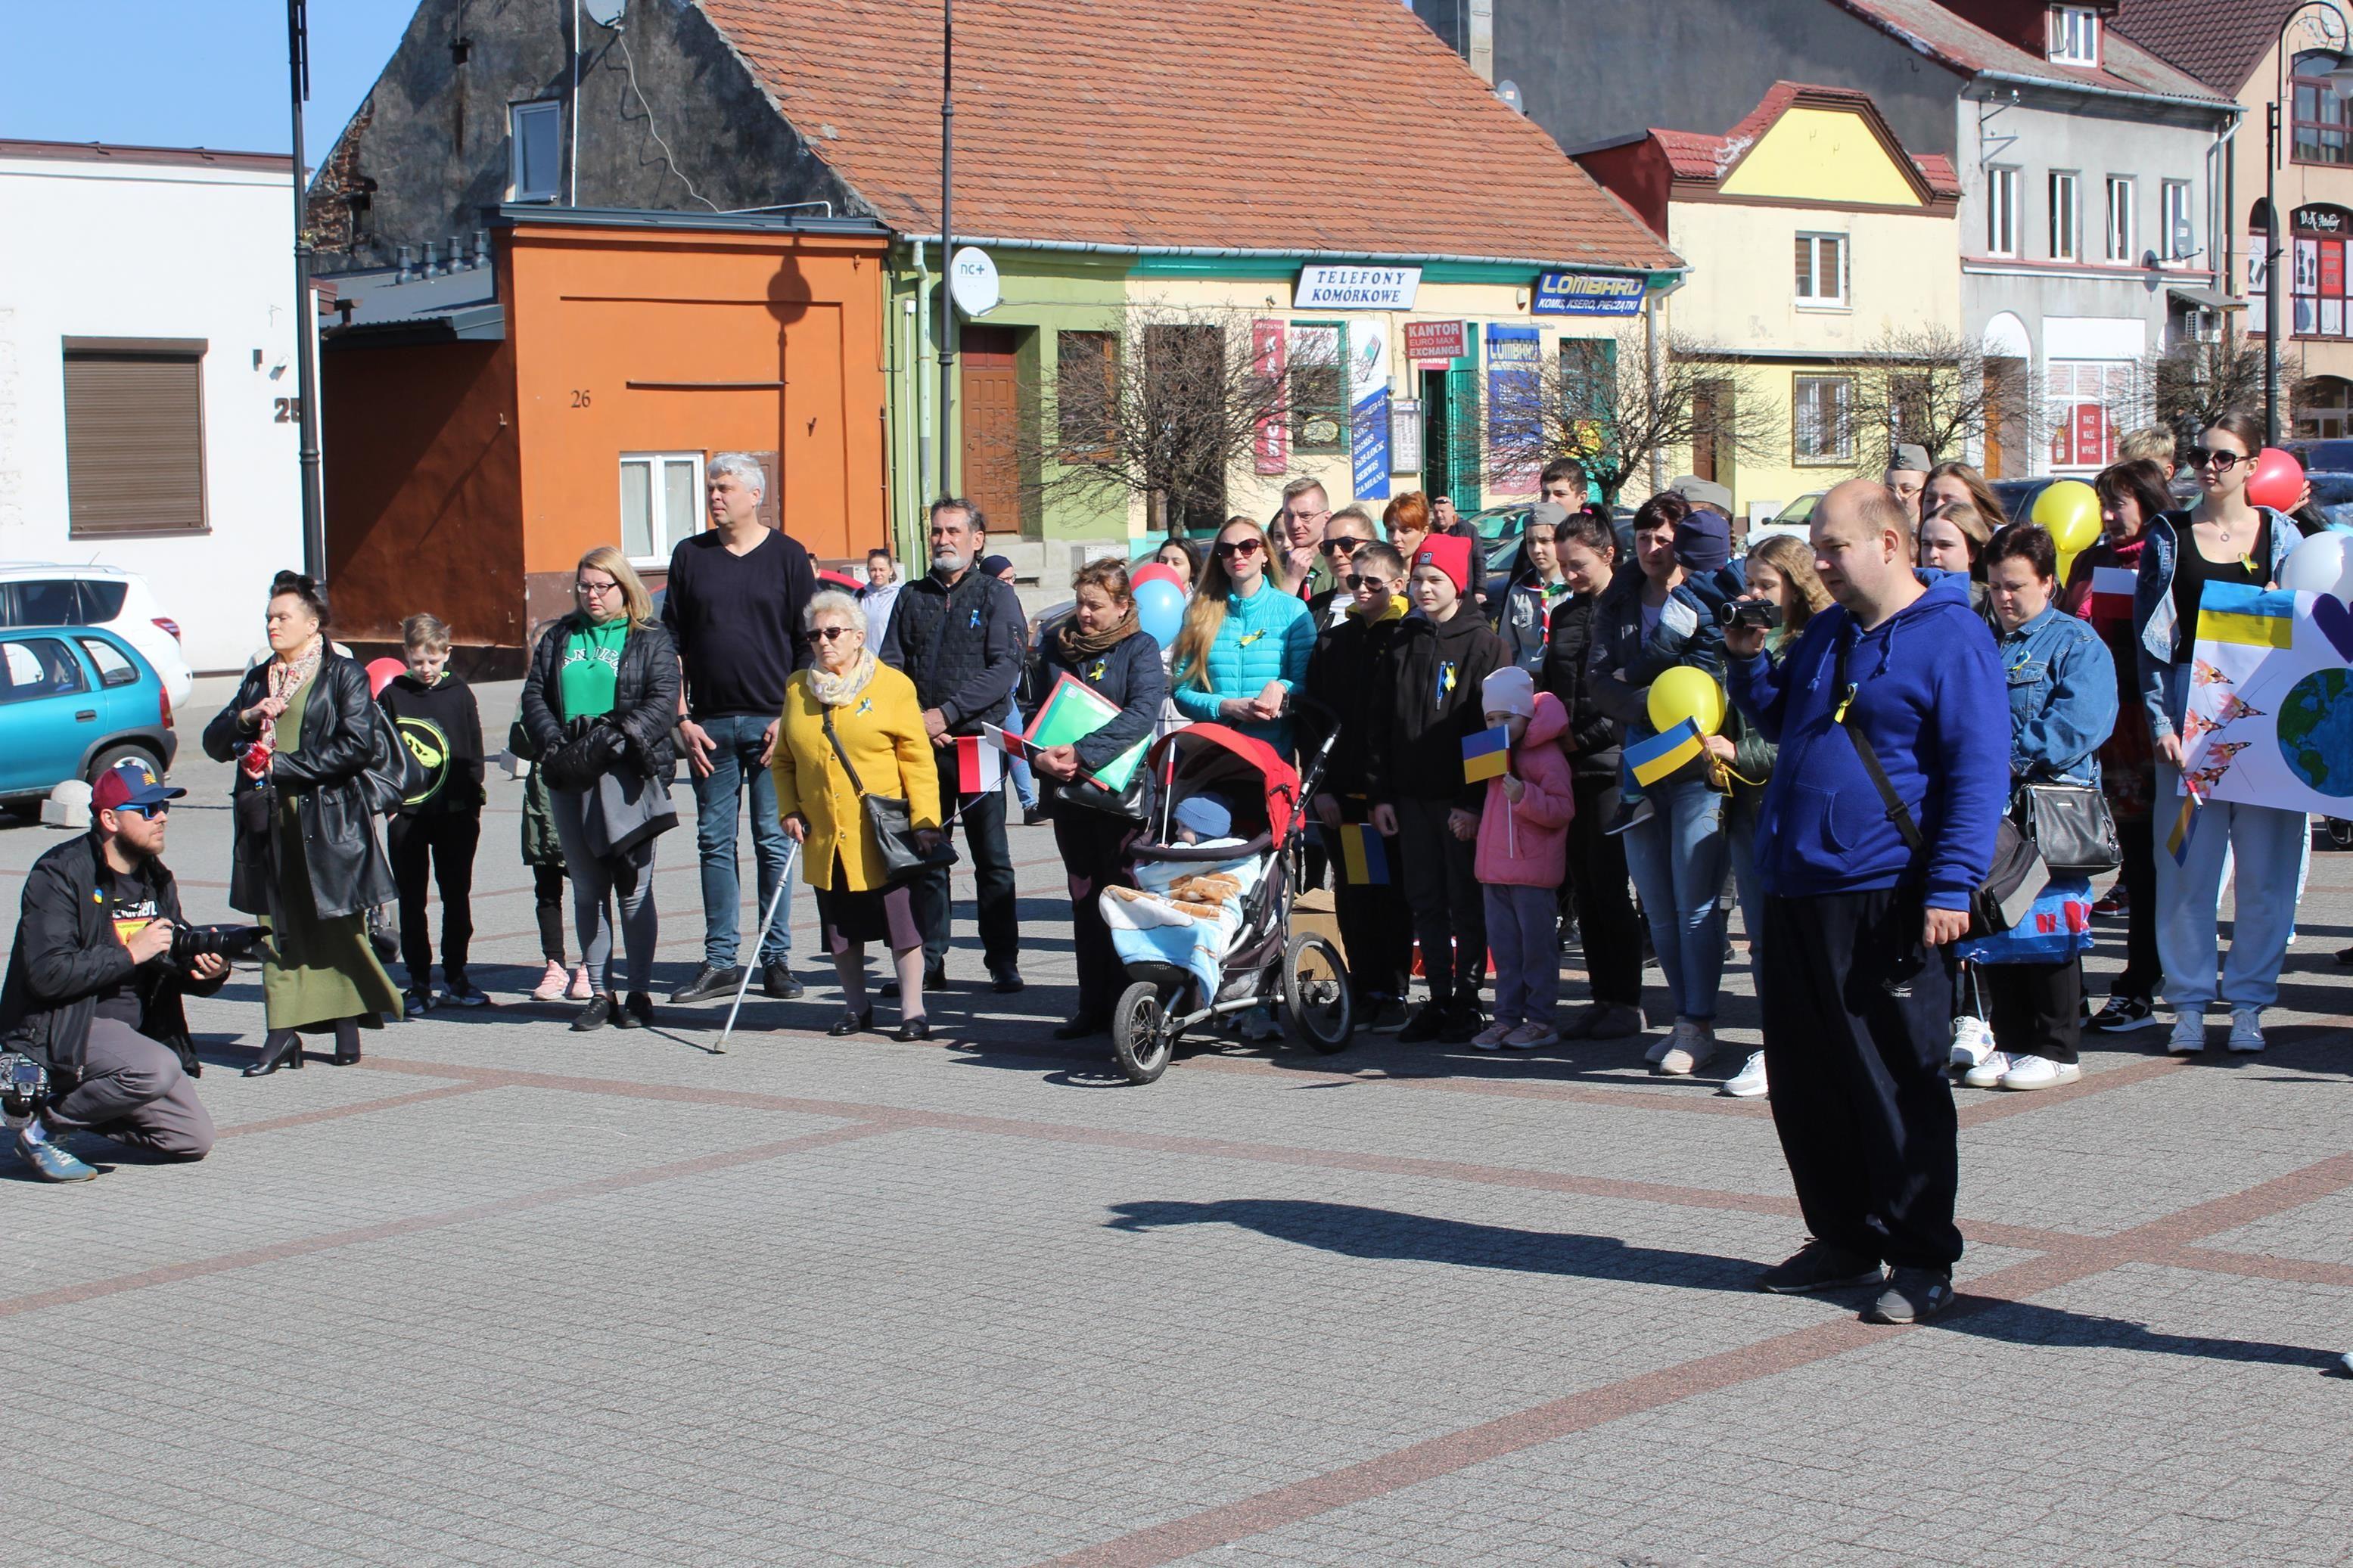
[769,590,941,1039]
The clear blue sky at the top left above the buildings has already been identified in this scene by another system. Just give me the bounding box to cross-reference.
[0,0,416,162]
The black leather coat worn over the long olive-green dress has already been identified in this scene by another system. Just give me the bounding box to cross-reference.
[205,649,398,921]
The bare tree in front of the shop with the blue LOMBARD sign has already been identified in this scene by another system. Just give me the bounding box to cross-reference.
[1487,327,1776,503]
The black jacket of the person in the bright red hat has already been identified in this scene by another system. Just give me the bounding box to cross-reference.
[1365,600,1511,811]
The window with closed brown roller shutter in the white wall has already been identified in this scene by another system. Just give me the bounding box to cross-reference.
[64,339,205,540]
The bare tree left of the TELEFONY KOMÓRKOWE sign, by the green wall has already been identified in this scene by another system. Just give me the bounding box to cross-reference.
[998,306,1348,534]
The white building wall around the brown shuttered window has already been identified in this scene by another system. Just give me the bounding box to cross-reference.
[0,148,301,672]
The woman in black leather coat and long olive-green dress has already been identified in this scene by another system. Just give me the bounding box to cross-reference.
[205,571,400,1076]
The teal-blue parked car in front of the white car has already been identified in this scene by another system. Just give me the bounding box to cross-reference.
[0,626,179,804]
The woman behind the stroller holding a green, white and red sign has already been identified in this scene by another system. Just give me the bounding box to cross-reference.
[1030,560,1167,1039]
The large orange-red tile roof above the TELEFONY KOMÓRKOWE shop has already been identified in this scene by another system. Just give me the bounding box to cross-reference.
[697,0,1680,270]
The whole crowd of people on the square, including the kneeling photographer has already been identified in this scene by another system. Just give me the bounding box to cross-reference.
[0,416,2343,1321]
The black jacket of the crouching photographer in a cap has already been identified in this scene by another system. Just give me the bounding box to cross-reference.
[0,832,228,1072]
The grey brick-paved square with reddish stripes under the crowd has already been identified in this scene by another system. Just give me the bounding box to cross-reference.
[0,689,2353,1566]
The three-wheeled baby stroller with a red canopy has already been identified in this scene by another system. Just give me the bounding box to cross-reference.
[1104,724,1355,1084]
